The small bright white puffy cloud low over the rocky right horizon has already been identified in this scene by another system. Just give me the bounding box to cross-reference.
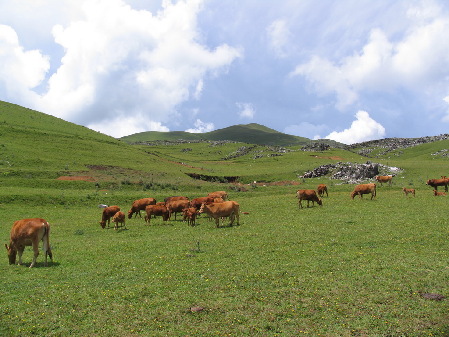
[324,111,385,144]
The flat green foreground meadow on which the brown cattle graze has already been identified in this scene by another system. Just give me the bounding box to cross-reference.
[0,184,449,336]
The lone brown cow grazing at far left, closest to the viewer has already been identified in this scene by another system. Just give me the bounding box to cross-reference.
[5,218,53,268]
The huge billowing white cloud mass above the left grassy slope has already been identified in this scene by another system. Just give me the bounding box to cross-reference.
[0,0,240,134]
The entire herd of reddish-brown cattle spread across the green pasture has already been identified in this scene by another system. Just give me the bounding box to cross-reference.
[5,175,449,268]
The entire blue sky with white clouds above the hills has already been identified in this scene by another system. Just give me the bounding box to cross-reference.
[0,0,449,144]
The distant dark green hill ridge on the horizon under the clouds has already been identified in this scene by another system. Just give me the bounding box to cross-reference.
[121,123,311,146]
